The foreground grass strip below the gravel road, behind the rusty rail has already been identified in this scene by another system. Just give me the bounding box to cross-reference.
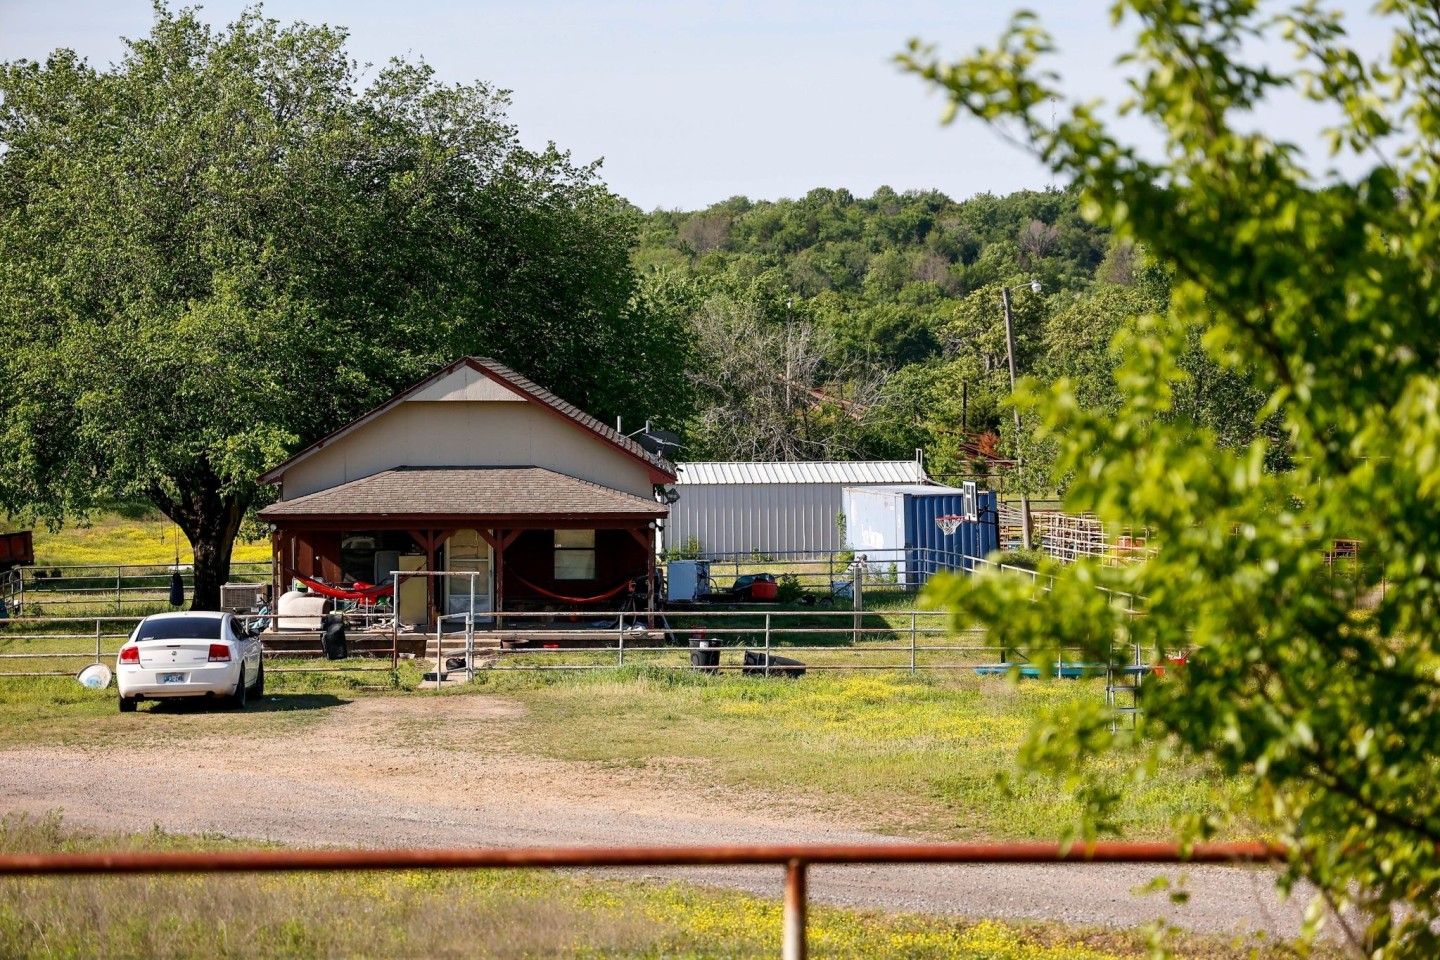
[0,816,1307,960]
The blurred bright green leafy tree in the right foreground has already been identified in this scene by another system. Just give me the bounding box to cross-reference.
[901,0,1440,957]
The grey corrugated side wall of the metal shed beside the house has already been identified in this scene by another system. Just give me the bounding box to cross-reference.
[662,484,844,556]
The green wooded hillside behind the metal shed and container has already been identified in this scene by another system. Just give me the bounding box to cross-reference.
[632,187,1278,488]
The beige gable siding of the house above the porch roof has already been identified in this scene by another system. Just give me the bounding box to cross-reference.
[282,402,652,499]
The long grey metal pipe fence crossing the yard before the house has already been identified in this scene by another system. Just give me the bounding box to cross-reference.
[0,610,1134,679]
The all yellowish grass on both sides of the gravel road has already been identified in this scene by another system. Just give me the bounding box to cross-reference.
[0,661,1280,960]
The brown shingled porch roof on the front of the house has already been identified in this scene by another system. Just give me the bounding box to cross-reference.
[259,466,670,521]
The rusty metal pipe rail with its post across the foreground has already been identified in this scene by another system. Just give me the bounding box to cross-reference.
[0,842,1290,960]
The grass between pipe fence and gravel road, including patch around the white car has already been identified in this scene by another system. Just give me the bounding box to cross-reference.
[0,664,1228,839]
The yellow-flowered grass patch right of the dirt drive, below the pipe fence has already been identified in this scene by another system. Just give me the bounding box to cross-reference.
[466,668,1244,839]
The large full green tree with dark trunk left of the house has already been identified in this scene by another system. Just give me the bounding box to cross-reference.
[0,6,673,607]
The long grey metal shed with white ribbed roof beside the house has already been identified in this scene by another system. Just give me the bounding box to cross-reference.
[661,461,930,556]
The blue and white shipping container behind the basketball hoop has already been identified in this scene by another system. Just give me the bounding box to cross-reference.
[844,485,999,589]
